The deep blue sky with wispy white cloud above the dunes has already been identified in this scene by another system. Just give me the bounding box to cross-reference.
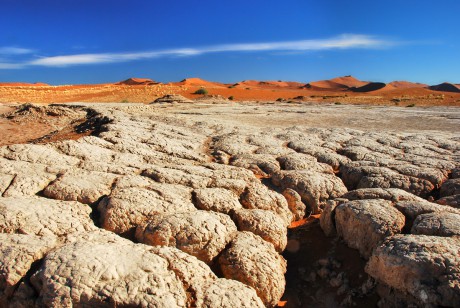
[0,0,460,84]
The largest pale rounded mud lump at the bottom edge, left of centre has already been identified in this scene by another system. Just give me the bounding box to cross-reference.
[31,233,187,307]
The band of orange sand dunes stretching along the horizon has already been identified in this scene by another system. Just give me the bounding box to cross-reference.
[0,78,460,106]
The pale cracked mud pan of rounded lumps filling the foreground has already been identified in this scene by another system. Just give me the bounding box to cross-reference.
[0,102,460,307]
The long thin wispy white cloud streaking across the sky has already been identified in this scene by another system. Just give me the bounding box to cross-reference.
[0,34,395,69]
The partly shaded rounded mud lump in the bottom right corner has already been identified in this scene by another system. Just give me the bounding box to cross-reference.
[366,234,460,307]
